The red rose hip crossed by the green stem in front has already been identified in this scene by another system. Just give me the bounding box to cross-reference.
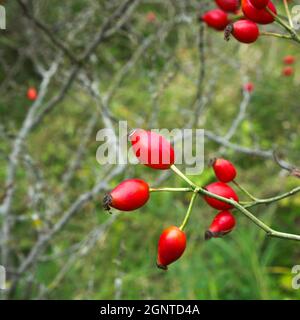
[204,182,239,210]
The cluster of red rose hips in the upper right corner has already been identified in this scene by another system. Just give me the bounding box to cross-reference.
[200,0,277,43]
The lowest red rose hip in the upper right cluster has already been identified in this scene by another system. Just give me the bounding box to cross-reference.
[225,20,259,43]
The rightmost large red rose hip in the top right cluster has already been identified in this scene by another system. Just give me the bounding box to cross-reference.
[242,0,277,24]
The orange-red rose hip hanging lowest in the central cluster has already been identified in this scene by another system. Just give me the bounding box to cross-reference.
[157,226,186,270]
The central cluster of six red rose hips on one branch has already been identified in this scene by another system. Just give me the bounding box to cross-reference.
[103,129,239,270]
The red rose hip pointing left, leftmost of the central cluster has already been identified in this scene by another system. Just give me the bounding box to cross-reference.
[103,179,149,211]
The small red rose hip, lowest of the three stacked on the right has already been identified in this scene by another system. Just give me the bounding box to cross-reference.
[205,211,236,240]
